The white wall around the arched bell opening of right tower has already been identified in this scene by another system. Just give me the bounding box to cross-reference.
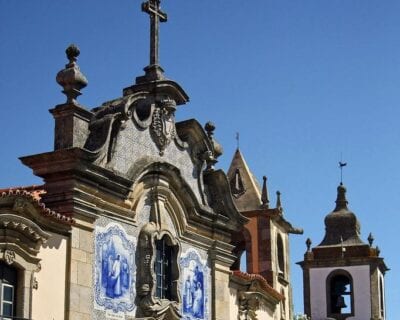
[310,266,371,320]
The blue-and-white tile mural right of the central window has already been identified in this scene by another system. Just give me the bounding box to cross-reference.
[180,249,209,320]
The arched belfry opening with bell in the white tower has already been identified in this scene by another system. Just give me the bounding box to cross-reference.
[327,270,354,319]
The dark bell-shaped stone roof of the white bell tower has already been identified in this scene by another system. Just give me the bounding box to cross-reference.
[319,183,364,246]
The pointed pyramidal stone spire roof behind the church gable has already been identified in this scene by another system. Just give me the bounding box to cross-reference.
[228,148,262,212]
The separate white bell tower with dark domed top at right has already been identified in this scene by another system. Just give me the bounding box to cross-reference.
[298,183,389,320]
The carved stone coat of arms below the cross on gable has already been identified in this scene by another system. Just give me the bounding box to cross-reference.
[150,99,176,156]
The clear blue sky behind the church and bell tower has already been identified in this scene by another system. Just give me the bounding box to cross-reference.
[0,0,400,320]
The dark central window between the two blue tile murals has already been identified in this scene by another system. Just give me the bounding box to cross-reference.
[154,236,172,300]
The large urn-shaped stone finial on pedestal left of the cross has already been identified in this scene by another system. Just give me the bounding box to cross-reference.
[56,44,88,104]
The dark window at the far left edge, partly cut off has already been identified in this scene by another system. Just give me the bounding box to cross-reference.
[0,262,17,320]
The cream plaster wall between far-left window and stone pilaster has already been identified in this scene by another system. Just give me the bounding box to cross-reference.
[32,233,67,320]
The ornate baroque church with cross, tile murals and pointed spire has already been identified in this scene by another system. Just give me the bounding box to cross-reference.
[0,0,300,320]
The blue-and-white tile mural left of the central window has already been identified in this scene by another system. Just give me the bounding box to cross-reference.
[94,224,136,313]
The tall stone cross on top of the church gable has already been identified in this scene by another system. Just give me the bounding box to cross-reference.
[142,0,167,66]
